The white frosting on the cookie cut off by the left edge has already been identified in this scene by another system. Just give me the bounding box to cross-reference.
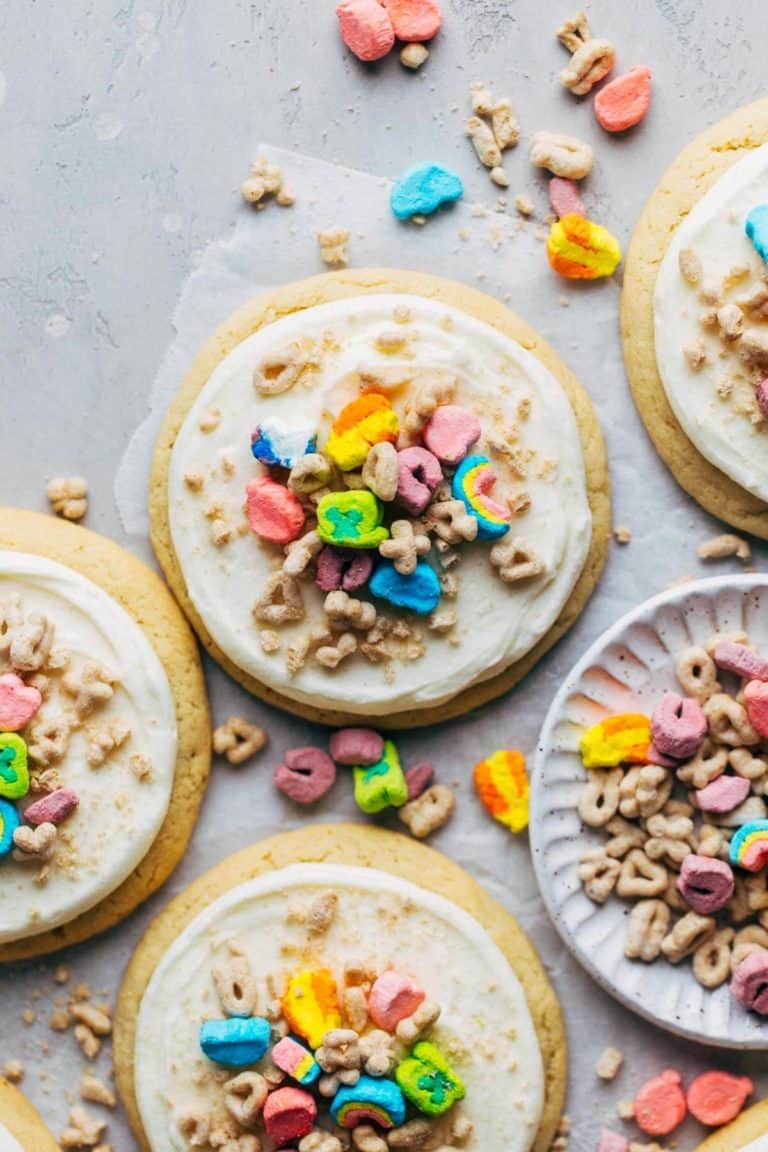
[0,552,176,941]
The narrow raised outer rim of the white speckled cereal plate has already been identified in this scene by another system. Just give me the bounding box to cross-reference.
[530,573,768,1052]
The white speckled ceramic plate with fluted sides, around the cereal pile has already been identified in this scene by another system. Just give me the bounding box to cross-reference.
[530,575,768,1048]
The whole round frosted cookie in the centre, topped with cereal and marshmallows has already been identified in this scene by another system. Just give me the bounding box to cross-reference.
[151,264,608,727]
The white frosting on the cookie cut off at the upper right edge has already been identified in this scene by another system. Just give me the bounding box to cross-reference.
[654,145,768,501]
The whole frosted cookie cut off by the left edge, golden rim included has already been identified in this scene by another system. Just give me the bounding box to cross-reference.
[0,509,210,961]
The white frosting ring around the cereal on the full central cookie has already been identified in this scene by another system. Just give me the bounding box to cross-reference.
[168,294,591,715]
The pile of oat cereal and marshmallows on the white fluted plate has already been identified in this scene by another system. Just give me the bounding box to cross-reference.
[579,635,768,1018]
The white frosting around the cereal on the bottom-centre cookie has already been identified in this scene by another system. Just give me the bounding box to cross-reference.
[135,864,543,1152]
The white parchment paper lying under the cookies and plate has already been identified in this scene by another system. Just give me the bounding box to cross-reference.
[6,147,768,1152]
